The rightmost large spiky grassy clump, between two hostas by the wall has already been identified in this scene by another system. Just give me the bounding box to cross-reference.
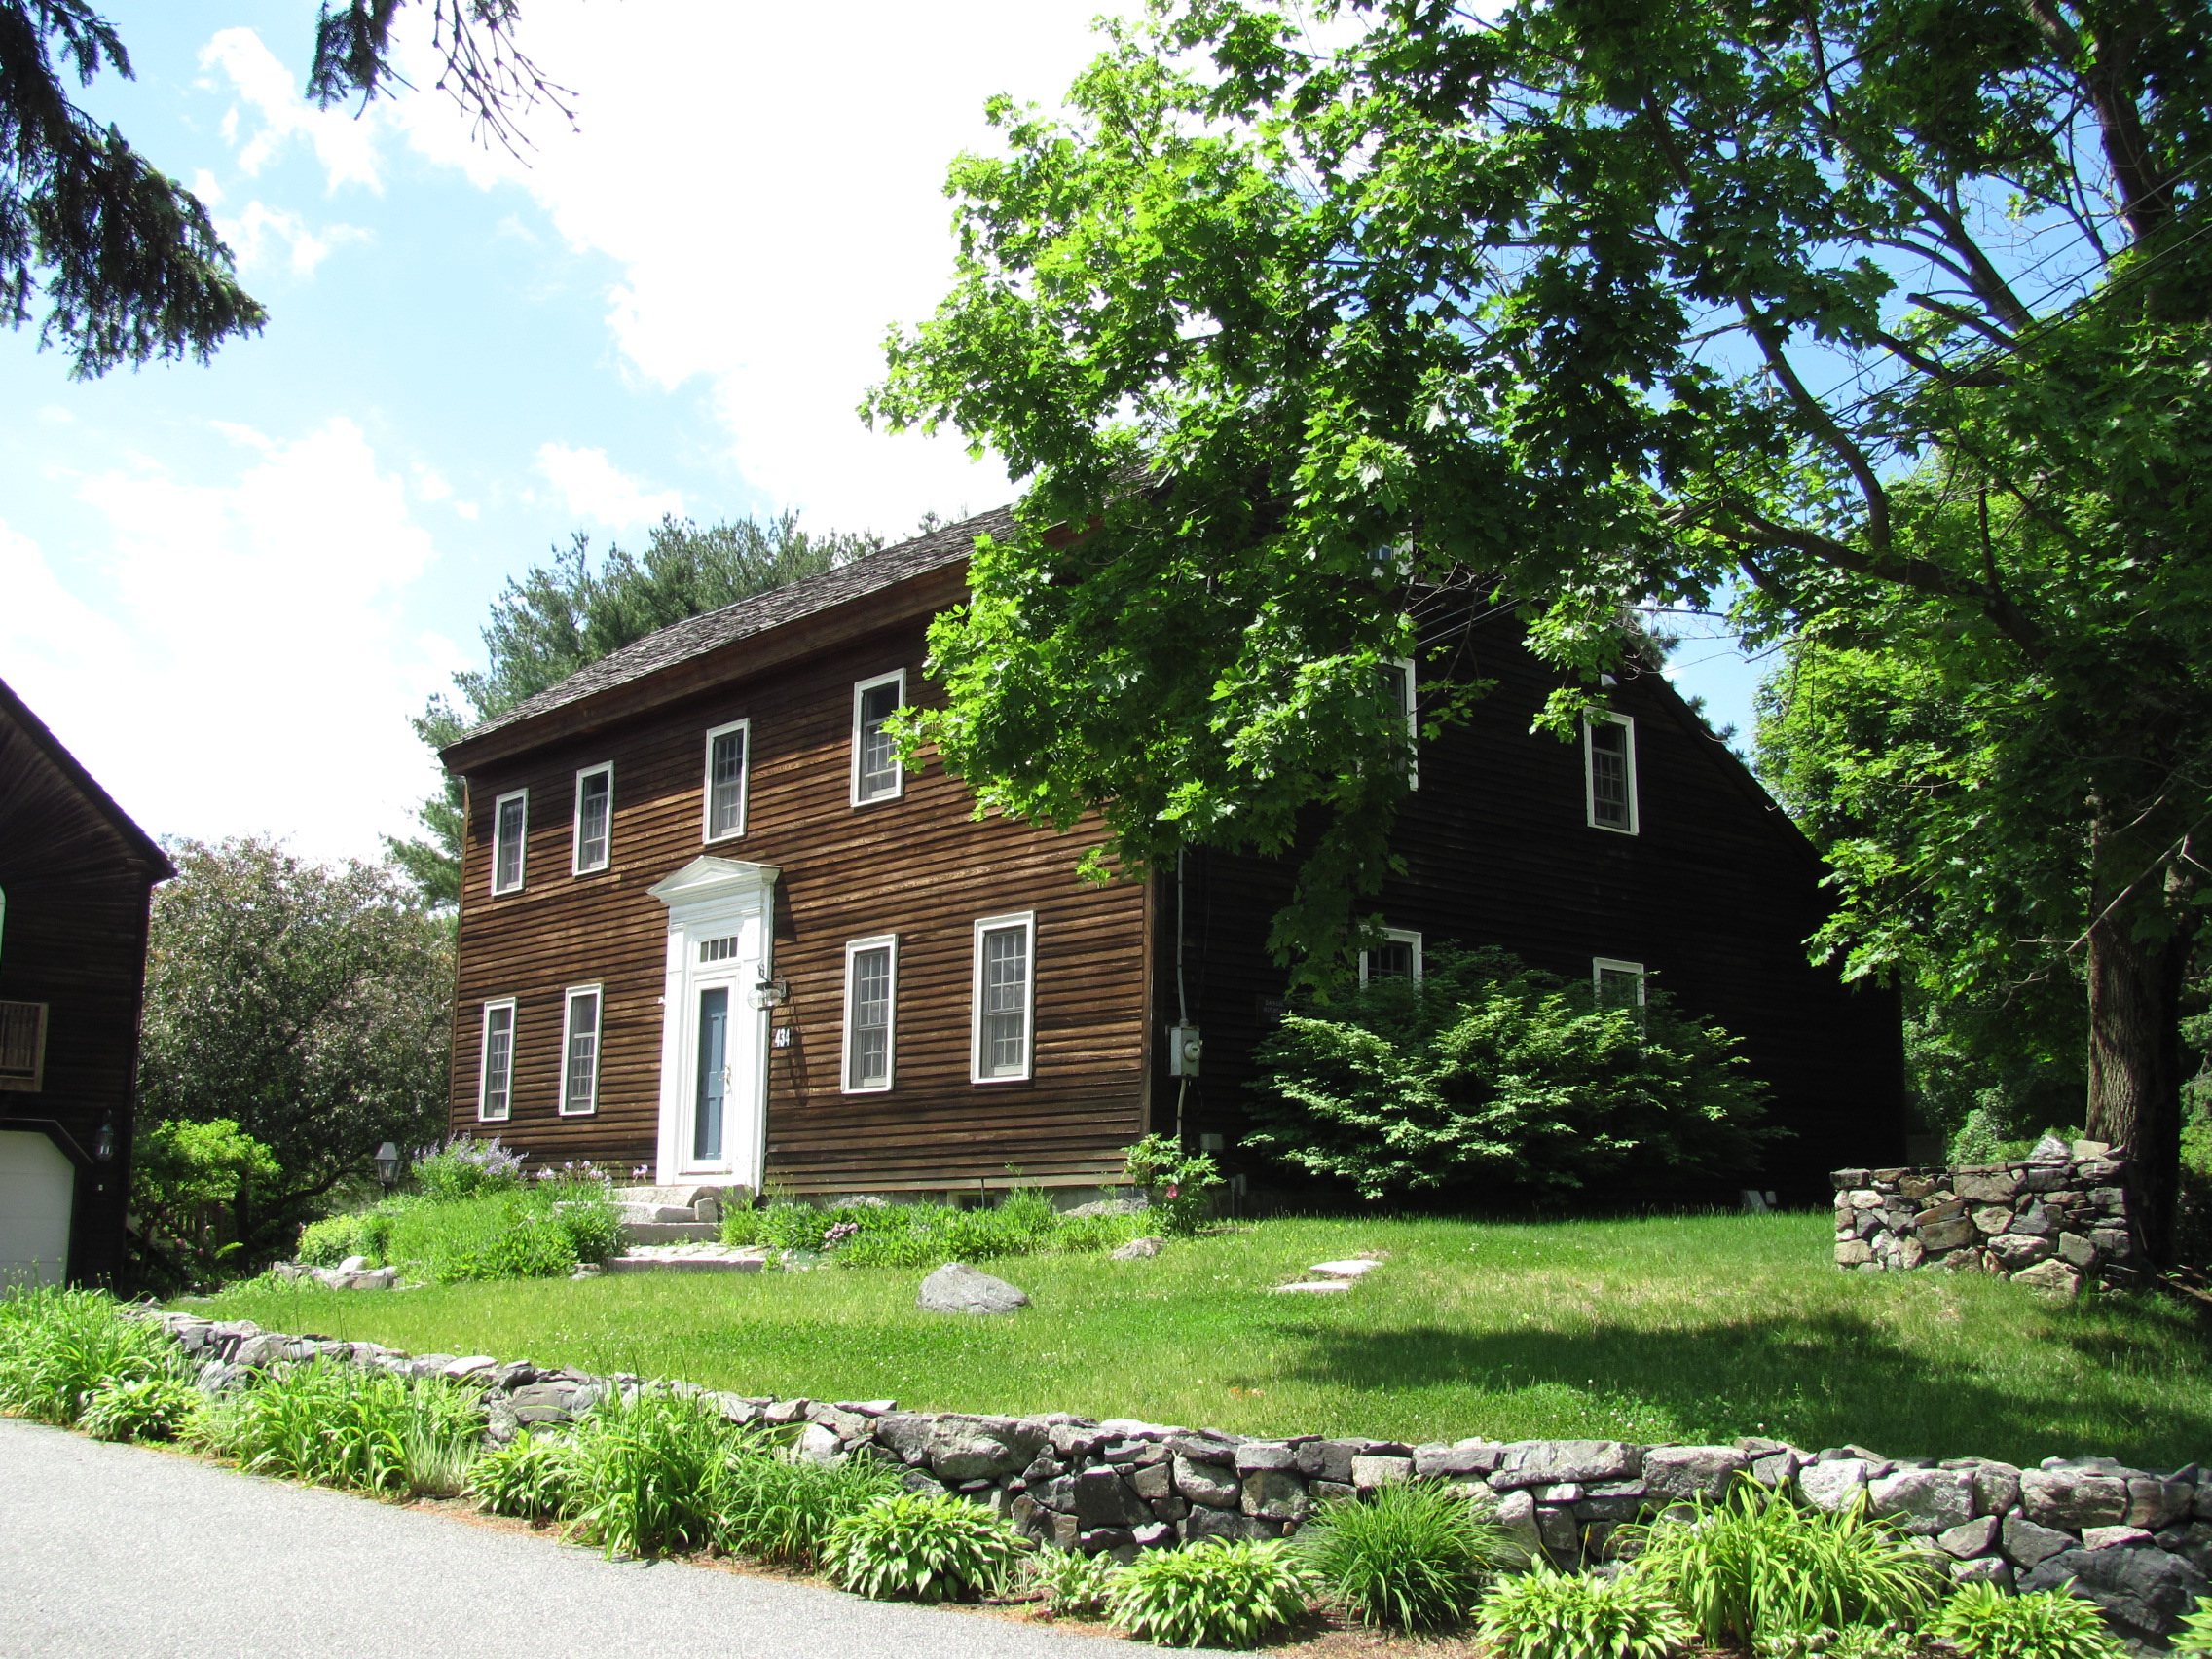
[1633,1480,1940,1643]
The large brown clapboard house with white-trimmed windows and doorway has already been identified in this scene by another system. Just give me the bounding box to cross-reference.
[445,513,1904,1198]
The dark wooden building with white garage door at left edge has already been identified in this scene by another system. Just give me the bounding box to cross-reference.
[0,685,177,1283]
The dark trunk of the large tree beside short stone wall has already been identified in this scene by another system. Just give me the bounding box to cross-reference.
[2088,902,2190,1266]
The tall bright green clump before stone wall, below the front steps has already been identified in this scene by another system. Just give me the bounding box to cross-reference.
[569,1389,756,1557]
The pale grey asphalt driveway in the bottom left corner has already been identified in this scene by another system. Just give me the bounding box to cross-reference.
[0,1418,1146,1659]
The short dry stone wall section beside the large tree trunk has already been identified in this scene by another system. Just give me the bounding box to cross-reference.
[1833,1139,2146,1296]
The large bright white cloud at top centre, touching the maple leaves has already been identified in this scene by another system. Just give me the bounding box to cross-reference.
[398,0,1124,534]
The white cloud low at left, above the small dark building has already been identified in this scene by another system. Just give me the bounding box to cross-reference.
[0,418,464,859]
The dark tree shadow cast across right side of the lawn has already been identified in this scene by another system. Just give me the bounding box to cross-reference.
[1285,1309,2212,1469]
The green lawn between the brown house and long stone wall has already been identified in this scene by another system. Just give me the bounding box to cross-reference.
[190,1212,2212,1469]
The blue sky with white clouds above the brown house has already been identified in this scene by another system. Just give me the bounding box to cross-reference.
[0,0,1750,859]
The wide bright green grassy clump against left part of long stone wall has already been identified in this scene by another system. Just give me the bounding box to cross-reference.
[195,1363,482,1497]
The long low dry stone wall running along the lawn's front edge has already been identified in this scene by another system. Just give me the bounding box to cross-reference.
[148,1309,2212,1637]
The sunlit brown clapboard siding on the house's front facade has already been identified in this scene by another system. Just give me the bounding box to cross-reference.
[454,584,1148,1190]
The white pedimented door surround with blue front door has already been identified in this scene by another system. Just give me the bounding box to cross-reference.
[650,854,781,1193]
